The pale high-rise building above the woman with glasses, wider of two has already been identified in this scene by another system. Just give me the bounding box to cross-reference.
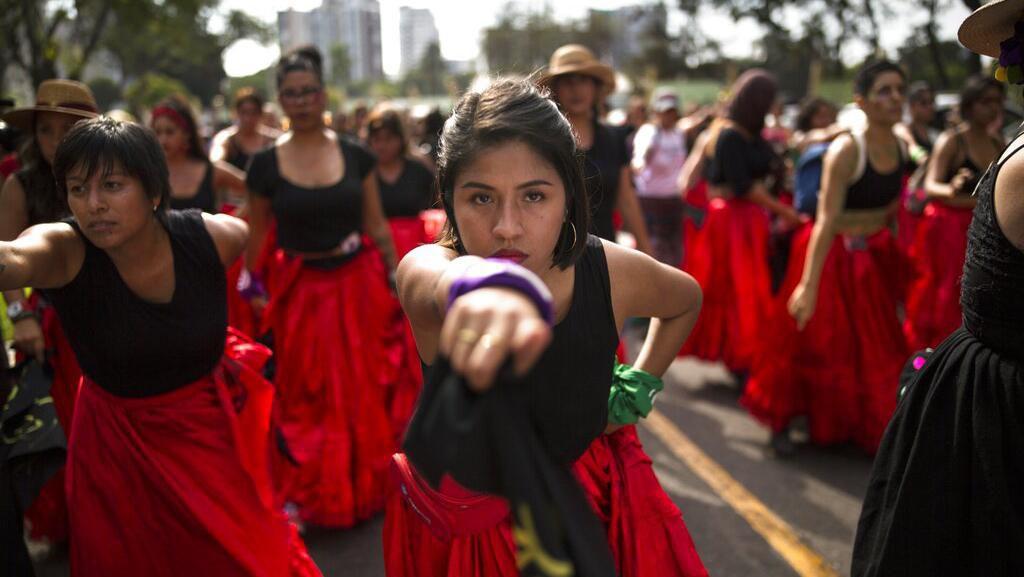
[278,0,384,82]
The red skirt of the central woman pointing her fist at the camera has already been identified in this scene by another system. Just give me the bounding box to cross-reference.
[384,426,708,577]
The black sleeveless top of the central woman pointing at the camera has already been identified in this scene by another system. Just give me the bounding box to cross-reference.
[424,235,618,464]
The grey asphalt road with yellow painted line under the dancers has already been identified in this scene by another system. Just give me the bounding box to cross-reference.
[32,360,870,577]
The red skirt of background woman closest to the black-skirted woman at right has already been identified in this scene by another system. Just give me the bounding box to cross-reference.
[903,202,974,351]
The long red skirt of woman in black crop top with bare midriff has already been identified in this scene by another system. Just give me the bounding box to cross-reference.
[740,224,909,453]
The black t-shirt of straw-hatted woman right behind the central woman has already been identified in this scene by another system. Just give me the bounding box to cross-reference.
[583,122,630,242]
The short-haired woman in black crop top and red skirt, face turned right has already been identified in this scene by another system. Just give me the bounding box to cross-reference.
[741,60,909,453]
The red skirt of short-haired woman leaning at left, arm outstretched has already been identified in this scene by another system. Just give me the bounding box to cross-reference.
[67,331,319,577]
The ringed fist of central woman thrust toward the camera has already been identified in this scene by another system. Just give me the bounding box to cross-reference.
[439,287,552,393]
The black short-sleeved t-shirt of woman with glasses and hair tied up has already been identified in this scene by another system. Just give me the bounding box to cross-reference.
[246,138,377,252]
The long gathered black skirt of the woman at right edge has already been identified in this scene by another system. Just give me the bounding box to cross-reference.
[852,328,1024,577]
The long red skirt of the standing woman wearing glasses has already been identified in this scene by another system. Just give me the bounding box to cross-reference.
[264,250,396,527]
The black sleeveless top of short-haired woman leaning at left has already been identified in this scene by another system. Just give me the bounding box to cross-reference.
[44,210,227,397]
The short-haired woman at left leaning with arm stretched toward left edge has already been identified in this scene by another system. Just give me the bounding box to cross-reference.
[0,118,319,577]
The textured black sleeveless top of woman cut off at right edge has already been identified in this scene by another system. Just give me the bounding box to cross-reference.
[961,147,1024,363]
